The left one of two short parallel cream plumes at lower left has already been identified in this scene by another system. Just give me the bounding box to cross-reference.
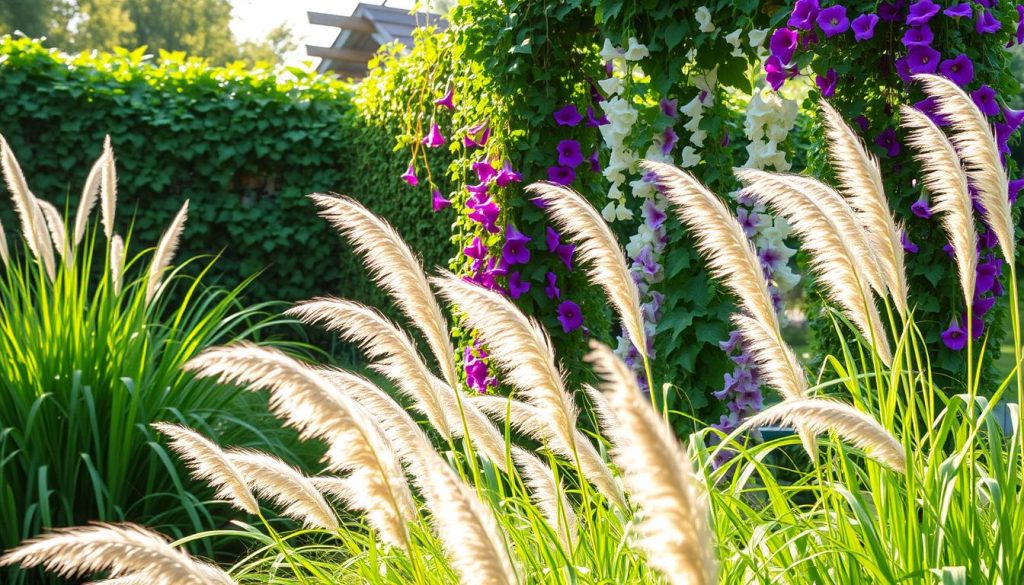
[151,422,259,514]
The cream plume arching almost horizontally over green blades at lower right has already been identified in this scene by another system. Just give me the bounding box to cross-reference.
[739,399,906,473]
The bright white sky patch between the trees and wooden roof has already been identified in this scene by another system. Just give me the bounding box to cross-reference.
[231,0,414,65]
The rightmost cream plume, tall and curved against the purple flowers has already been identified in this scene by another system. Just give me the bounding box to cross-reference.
[913,74,1017,264]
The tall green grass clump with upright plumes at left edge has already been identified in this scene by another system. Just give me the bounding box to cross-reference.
[0,137,299,583]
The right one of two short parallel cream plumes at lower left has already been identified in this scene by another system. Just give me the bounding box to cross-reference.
[226,449,338,531]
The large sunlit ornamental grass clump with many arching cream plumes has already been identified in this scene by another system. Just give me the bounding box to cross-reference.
[6,76,1024,585]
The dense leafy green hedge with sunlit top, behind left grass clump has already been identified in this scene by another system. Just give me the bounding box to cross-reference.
[0,37,451,303]
